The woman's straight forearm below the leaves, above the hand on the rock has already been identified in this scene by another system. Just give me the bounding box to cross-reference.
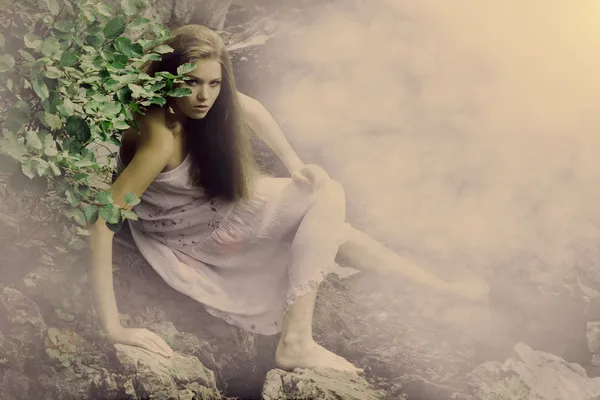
[90,222,121,333]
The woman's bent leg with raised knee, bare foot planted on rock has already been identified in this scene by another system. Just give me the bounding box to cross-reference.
[275,181,362,372]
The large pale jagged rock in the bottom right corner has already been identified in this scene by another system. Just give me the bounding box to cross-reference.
[471,342,600,400]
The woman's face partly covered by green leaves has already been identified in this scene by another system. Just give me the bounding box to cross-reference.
[174,60,222,119]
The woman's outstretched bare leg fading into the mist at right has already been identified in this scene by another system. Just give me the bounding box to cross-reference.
[335,228,489,300]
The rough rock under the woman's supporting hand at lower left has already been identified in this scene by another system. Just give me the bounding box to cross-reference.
[115,344,220,399]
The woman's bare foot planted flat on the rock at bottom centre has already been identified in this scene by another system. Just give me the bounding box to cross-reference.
[275,340,364,374]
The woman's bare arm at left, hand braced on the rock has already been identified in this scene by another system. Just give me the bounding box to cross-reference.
[90,110,174,355]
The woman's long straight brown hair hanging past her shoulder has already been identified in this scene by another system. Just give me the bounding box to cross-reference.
[142,25,258,201]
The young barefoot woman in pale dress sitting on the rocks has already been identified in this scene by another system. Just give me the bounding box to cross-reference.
[90,25,487,372]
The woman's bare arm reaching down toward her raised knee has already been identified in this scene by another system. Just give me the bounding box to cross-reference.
[238,92,304,173]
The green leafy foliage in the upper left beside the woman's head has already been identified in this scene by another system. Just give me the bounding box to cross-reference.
[0,0,194,245]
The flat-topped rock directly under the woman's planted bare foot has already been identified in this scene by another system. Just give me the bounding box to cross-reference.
[262,369,385,400]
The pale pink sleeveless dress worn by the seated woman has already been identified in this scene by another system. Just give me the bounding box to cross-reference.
[117,152,349,335]
